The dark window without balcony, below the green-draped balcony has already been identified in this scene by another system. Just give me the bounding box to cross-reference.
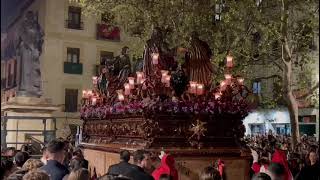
[65,89,78,112]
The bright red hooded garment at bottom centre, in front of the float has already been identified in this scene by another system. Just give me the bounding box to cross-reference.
[152,154,178,180]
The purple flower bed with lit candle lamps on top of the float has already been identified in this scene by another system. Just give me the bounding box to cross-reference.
[80,53,251,119]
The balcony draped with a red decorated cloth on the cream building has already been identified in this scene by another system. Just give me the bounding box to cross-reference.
[97,24,120,42]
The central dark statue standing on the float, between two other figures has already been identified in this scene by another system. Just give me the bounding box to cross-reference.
[143,27,177,76]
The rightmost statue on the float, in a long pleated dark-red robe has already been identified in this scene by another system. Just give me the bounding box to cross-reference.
[185,32,214,85]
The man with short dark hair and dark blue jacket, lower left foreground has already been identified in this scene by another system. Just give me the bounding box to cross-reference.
[41,140,69,180]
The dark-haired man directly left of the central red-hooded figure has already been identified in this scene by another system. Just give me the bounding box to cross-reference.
[127,150,154,180]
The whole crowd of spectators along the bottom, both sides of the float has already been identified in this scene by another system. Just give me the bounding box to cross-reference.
[0,134,320,180]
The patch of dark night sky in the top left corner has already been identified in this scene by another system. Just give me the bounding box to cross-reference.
[1,0,28,32]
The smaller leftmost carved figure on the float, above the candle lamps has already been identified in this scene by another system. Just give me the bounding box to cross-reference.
[114,46,131,88]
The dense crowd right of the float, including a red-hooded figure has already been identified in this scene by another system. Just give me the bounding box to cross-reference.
[244,133,320,180]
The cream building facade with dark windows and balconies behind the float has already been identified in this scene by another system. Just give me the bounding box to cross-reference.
[1,0,132,137]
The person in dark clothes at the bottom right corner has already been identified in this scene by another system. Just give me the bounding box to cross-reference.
[296,151,320,180]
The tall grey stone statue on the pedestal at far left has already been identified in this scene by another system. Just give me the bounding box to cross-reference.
[17,11,44,97]
